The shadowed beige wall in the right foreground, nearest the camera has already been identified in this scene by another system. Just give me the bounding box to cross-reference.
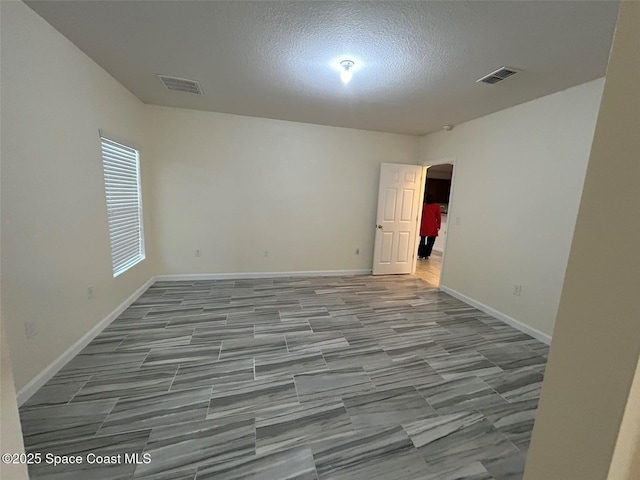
[524,2,640,480]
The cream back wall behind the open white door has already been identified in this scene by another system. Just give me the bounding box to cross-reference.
[146,106,419,274]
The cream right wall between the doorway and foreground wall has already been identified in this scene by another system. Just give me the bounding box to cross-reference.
[420,80,608,335]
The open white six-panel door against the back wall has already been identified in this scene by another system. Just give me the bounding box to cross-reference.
[372,163,423,275]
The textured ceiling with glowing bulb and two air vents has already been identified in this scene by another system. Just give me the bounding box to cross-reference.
[26,0,618,135]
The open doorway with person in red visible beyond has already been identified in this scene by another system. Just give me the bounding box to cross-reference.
[415,158,453,287]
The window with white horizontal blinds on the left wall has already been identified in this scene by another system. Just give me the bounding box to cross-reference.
[101,137,144,277]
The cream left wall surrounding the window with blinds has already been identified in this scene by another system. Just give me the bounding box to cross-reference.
[0,1,154,390]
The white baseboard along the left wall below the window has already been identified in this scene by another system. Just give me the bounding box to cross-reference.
[16,277,155,406]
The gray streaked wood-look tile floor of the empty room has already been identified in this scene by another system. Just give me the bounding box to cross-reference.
[20,276,548,480]
